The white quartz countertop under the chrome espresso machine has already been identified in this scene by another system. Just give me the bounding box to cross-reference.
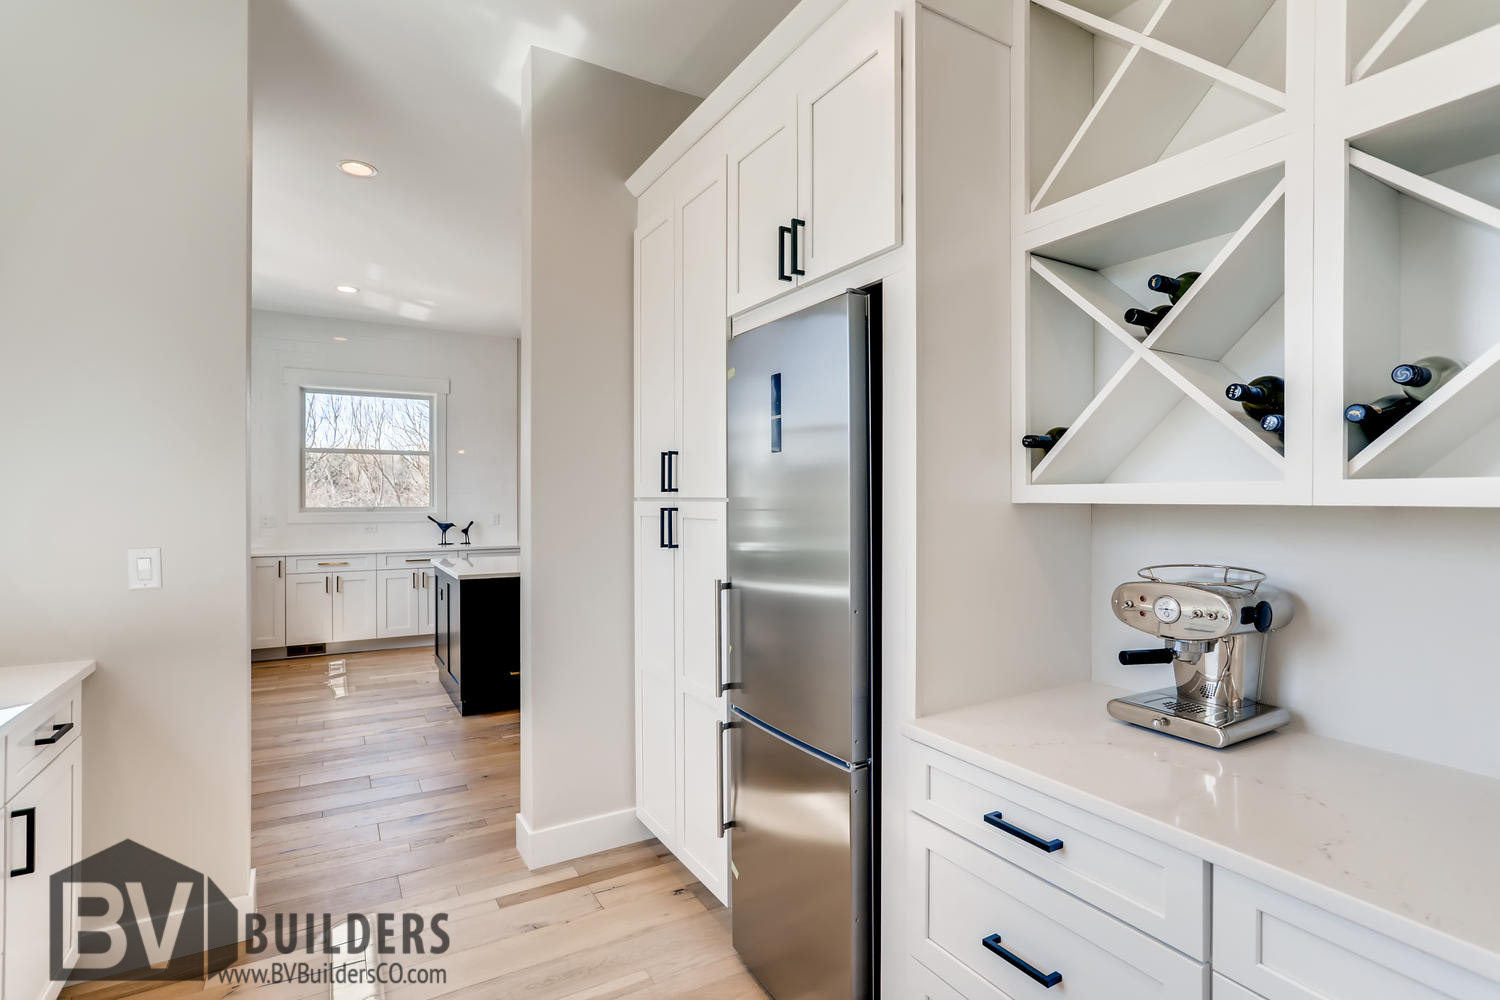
[903,684,1500,981]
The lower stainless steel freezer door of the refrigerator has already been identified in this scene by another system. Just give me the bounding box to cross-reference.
[731,712,873,1000]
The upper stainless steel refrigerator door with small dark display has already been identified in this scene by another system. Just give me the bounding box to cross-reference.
[728,292,872,762]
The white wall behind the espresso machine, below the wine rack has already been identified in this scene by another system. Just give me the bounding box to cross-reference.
[1089,507,1500,777]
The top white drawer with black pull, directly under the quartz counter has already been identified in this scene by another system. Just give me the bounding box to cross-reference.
[909,744,1209,960]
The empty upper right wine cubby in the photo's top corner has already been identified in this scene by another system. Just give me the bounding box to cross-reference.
[1349,0,1500,81]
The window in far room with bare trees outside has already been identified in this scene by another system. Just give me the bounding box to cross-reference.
[302,388,435,510]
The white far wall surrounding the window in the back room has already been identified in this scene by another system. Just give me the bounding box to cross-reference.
[251,310,518,553]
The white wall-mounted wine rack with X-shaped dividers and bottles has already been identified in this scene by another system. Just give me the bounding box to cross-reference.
[1013,0,1500,507]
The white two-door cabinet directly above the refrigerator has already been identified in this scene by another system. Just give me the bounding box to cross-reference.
[725,3,902,313]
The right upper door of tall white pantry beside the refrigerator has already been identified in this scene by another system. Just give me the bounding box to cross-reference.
[675,157,729,498]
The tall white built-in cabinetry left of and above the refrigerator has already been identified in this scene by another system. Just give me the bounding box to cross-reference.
[635,0,902,904]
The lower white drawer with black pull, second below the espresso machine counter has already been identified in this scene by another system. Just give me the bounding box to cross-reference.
[911,816,1209,1000]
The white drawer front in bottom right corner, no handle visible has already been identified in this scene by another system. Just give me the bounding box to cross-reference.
[1214,868,1500,1000]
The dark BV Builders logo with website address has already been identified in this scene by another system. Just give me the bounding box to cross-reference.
[50,840,450,984]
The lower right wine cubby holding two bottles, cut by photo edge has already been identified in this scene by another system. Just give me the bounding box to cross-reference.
[1344,81,1500,487]
